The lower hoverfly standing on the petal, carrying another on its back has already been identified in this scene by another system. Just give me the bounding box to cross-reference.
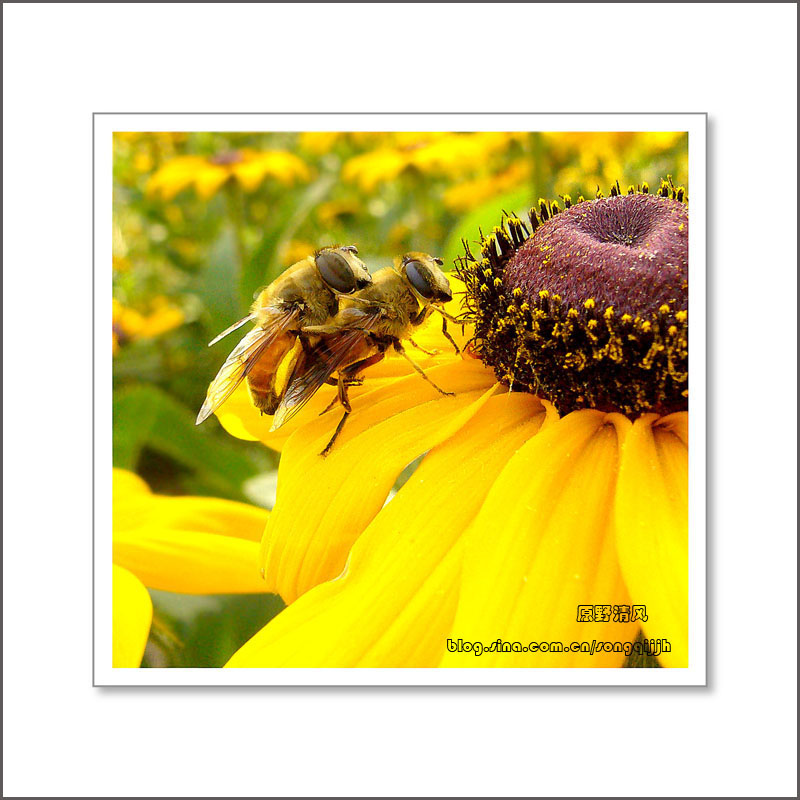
[271,253,459,457]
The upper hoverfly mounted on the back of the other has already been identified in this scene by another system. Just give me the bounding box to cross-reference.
[195,245,372,425]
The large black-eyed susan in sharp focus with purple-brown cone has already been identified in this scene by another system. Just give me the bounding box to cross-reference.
[200,183,689,667]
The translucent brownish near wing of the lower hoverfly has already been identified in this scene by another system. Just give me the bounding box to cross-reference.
[270,311,380,431]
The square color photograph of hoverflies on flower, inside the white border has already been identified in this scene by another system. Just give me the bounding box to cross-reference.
[104,116,705,683]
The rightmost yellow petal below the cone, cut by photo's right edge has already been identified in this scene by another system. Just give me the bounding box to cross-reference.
[615,412,689,667]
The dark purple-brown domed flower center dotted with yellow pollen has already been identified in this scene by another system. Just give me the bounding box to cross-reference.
[459,182,688,415]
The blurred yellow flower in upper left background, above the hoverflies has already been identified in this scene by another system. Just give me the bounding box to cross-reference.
[146,149,311,200]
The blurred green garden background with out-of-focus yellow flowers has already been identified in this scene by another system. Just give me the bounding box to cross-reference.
[112,132,688,666]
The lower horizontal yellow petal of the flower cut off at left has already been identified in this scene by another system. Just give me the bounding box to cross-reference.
[114,526,266,594]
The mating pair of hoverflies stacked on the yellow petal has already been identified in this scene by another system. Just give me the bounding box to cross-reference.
[196,245,459,457]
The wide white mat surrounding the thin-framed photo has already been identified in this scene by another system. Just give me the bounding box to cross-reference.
[3,3,796,796]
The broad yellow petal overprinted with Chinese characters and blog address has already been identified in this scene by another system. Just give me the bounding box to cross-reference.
[442,410,638,667]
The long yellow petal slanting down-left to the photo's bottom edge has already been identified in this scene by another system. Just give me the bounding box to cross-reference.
[228,392,545,667]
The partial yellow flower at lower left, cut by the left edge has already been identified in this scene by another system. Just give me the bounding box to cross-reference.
[112,469,267,667]
